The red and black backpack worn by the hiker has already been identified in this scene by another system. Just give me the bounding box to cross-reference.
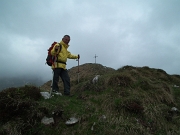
[46,41,62,66]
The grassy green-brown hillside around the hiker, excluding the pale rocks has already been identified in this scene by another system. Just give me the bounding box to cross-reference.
[0,63,180,135]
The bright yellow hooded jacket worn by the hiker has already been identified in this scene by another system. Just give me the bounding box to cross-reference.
[51,41,78,69]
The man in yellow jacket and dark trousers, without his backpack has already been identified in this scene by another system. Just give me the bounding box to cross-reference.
[51,35,80,96]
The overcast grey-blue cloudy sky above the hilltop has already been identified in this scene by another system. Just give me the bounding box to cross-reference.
[0,0,180,80]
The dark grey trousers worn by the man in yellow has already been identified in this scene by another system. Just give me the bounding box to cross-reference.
[52,68,70,95]
